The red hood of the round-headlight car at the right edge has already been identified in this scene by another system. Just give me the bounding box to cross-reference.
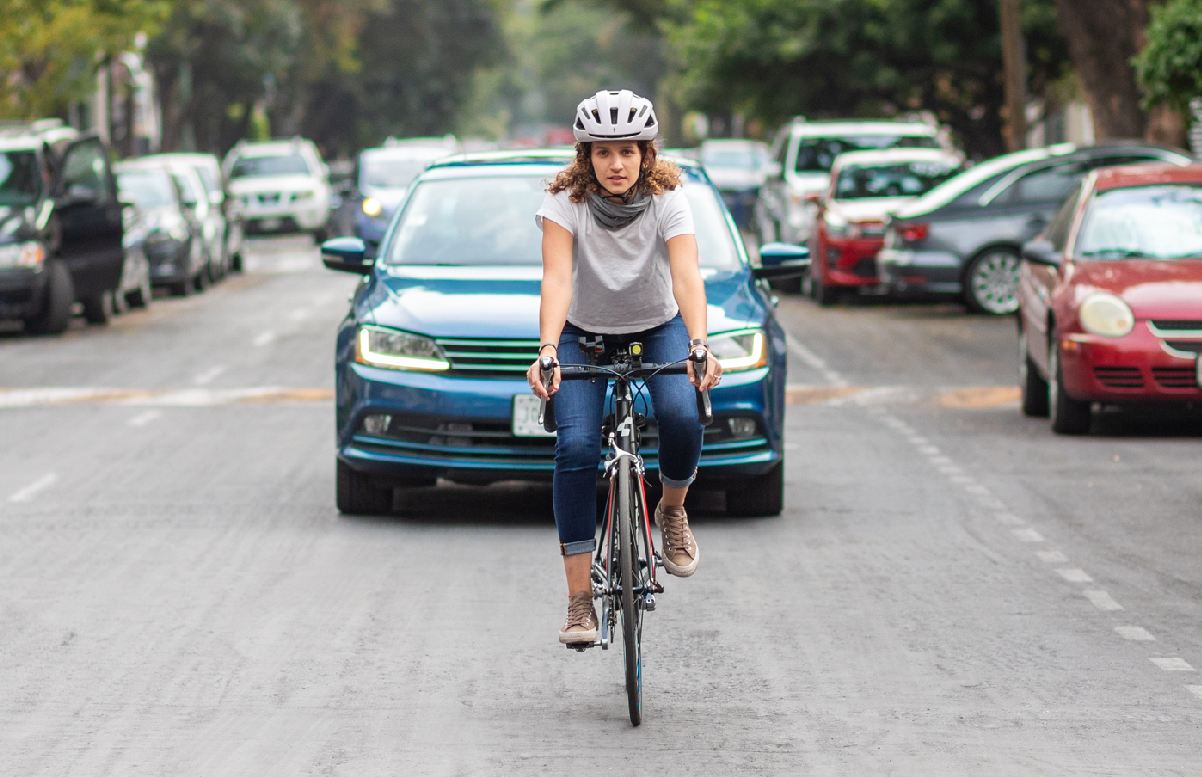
[1071,259,1202,320]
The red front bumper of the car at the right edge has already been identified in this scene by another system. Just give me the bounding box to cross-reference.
[1060,321,1202,402]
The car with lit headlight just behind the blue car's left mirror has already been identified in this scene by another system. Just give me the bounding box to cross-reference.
[335,138,454,251]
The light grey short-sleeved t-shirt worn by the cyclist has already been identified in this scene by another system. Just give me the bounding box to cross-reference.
[534,188,696,334]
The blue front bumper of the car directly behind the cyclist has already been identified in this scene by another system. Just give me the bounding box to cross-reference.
[338,363,781,482]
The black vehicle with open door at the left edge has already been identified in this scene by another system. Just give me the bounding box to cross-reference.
[0,119,125,333]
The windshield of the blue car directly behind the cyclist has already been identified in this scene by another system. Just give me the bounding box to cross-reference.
[386,173,740,269]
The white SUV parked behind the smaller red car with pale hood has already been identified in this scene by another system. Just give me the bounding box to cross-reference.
[755,119,941,245]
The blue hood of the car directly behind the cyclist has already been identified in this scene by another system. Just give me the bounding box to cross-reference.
[361,265,764,339]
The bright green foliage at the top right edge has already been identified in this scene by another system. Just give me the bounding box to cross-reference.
[1135,0,1202,114]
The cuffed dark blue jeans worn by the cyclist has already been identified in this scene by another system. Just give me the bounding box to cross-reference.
[552,314,703,556]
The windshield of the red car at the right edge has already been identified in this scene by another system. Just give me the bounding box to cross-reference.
[1075,184,1202,260]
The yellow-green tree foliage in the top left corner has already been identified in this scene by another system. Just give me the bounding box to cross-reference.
[0,0,171,118]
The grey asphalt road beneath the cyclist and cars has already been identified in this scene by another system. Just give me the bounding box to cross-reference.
[0,241,1202,777]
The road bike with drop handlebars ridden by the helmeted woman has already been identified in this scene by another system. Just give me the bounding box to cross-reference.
[538,338,713,725]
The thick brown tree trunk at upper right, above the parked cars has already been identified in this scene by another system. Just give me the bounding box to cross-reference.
[1055,0,1149,140]
